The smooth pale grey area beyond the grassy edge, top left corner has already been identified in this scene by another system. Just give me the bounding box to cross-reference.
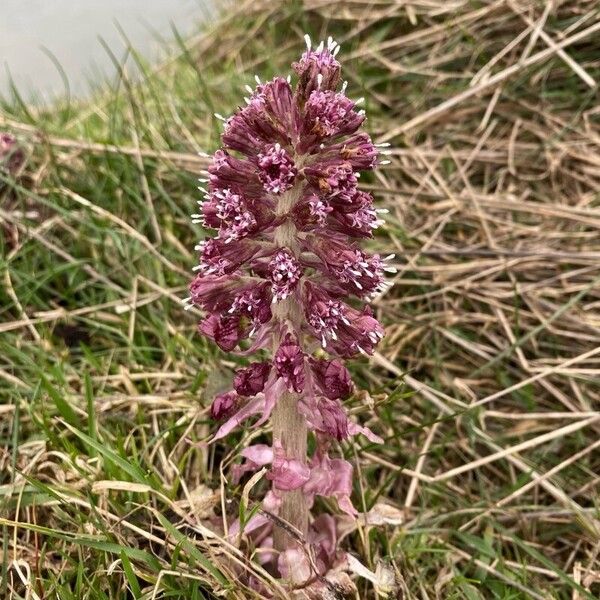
[0,0,208,99]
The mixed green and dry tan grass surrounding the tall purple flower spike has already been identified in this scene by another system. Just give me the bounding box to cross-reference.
[0,0,600,600]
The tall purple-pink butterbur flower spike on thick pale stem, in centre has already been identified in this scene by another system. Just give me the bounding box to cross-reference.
[188,36,393,586]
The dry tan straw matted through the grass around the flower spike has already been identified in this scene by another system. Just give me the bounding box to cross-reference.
[0,0,600,600]
